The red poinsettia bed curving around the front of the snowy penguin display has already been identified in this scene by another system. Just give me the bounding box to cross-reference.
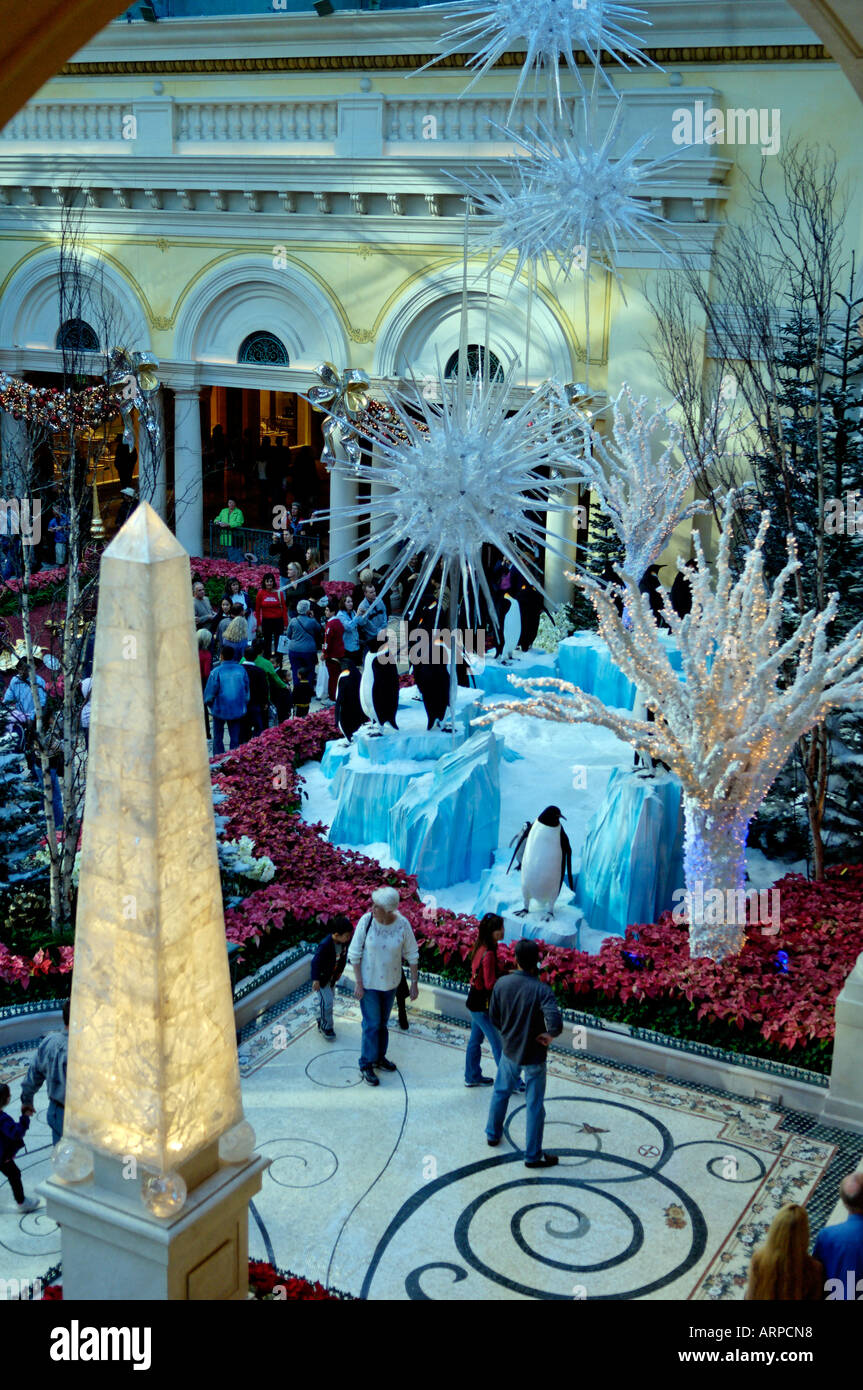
[6,689,863,1072]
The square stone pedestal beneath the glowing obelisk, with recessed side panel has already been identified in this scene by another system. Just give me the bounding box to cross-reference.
[39,1156,270,1301]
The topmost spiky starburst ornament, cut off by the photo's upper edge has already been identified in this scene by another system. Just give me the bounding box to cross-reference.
[418,0,657,117]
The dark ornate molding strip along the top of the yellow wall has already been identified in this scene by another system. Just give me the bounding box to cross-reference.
[57,43,834,78]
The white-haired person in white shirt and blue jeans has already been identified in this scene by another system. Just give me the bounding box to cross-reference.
[347,888,420,1086]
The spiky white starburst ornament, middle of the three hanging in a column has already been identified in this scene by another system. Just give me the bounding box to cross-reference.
[449,101,680,284]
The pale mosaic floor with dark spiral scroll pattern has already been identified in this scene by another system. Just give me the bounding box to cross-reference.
[0,994,863,1300]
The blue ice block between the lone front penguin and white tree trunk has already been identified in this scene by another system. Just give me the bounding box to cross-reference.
[575,767,684,937]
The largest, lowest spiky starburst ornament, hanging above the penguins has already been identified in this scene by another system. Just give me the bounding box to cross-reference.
[305,363,577,626]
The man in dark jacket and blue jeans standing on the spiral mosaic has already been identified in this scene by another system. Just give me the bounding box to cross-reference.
[485,941,563,1168]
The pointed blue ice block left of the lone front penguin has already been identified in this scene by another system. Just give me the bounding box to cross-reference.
[386,730,500,888]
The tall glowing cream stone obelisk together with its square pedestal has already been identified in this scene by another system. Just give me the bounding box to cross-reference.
[43,503,267,1298]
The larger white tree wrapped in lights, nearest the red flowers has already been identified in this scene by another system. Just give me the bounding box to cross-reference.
[482,496,863,960]
